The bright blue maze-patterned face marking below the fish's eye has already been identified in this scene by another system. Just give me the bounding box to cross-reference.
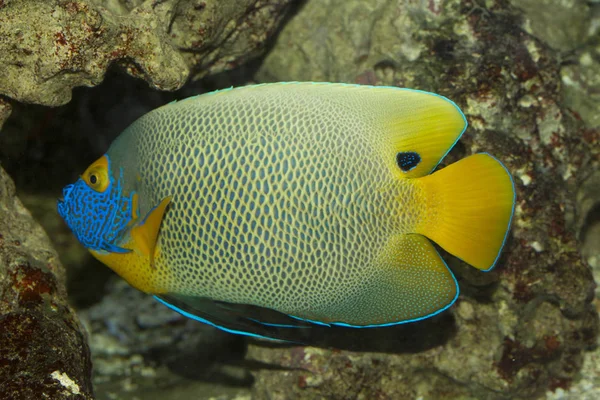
[57,156,133,253]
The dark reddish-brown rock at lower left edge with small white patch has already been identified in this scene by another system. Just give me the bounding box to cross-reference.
[0,168,93,400]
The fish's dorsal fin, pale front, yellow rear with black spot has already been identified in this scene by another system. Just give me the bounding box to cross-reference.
[176,82,467,178]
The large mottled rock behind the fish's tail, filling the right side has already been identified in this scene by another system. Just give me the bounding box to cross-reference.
[254,0,600,399]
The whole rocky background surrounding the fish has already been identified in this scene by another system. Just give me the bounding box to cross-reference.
[0,0,600,399]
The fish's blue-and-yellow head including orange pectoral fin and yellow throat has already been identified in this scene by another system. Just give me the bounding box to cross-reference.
[58,154,171,294]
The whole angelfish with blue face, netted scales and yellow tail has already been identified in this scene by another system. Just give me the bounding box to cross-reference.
[58,83,515,338]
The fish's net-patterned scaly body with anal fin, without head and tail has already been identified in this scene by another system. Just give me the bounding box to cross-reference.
[108,84,455,324]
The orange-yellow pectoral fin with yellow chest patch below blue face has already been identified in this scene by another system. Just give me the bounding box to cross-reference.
[90,197,171,294]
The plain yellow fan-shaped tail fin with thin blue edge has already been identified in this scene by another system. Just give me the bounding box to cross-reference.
[417,153,515,271]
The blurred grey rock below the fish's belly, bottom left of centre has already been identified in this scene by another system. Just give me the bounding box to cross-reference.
[80,278,252,400]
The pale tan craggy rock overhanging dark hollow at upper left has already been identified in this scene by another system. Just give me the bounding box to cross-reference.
[0,0,290,106]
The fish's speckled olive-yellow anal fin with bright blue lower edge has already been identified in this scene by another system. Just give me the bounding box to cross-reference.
[330,234,458,328]
